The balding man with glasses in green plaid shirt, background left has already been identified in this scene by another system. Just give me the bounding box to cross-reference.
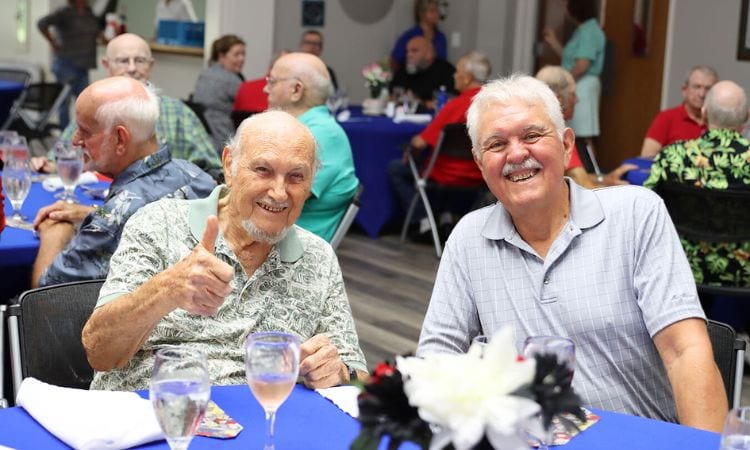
[31,33,222,179]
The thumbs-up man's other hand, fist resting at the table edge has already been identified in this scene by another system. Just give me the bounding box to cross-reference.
[299,334,349,389]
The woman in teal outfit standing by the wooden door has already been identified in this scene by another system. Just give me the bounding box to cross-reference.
[544,0,607,157]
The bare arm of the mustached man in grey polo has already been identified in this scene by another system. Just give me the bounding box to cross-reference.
[654,319,728,432]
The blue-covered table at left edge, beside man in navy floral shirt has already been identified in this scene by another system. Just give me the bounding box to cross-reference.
[0,178,109,302]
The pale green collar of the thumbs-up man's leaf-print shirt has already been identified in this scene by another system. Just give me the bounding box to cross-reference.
[188,184,304,263]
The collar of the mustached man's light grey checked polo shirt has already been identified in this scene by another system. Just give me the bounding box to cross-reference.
[482,177,604,240]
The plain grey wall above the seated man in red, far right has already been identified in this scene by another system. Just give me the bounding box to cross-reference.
[662,0,750,108]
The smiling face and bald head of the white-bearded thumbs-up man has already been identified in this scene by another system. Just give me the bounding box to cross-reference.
[223,111,315,242]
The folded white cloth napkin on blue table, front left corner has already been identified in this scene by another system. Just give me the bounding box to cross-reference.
[16,378,164,450]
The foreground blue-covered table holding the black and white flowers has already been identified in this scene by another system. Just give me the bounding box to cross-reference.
[0,385,719,450]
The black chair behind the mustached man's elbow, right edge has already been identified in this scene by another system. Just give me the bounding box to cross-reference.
[708,319,747,408]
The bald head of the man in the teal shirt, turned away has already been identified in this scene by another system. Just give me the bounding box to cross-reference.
[266,52,332,111]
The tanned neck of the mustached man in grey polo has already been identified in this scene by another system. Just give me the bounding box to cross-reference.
[508,183,570,259]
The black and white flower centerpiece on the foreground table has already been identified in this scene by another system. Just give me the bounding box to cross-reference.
[351,328,586,450]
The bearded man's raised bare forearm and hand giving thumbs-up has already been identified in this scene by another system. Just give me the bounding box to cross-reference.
[81,216,234,372]
